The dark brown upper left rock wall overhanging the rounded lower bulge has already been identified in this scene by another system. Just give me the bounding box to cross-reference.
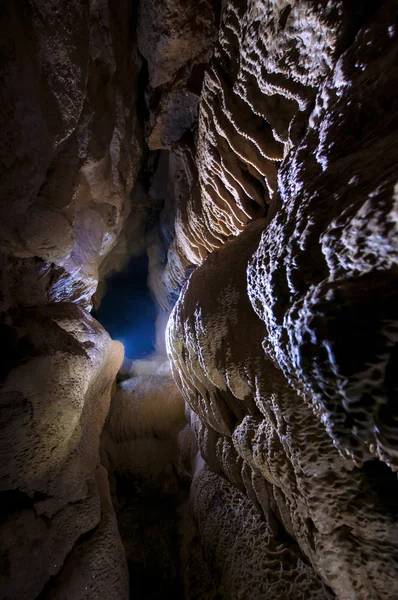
[0,0,141,310]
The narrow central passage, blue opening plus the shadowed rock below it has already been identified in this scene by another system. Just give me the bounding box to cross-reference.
[92,254,188,600]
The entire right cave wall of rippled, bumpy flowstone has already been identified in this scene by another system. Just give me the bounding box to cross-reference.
[168,2,398,600]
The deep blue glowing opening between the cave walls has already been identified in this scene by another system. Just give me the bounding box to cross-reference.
[93,254,156,359]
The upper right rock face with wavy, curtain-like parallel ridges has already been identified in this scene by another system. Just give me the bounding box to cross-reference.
[169,0,380,282]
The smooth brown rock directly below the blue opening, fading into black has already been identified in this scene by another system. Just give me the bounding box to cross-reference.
[101,357,186,600]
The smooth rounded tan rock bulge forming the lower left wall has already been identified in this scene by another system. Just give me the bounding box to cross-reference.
[0,303,127,600]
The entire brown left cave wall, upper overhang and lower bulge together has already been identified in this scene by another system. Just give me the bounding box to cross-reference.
[0,0,143,600]
